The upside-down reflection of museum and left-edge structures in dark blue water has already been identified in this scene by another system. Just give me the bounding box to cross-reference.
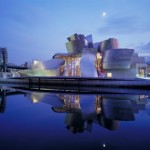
[0,90,149,133]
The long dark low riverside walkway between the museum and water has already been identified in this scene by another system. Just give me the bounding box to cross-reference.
[0,76,150,88]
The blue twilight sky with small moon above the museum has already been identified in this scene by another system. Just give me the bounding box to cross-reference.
[0,0,150,65]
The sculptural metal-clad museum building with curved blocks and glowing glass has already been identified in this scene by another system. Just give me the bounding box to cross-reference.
[19,34,147,78]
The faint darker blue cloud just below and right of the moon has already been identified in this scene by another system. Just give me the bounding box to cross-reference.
[98,15,150,34]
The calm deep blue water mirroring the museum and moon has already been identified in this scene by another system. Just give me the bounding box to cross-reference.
[0,90,150,150]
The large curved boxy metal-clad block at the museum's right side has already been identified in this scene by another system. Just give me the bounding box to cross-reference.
[103,49,134,69]
